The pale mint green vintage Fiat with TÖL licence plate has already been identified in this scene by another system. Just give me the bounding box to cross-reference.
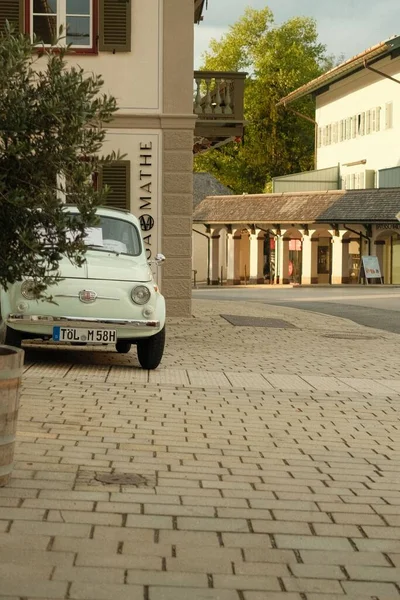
[0,207,165,369]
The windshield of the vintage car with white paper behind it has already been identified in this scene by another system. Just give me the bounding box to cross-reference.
[85,216,142,256]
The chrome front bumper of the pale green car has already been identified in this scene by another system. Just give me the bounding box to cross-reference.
[6,314,160,329]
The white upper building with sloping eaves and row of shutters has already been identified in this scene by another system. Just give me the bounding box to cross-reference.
[280,37,400,189]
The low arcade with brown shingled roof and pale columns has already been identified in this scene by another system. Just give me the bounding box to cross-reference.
[194,188,400,285]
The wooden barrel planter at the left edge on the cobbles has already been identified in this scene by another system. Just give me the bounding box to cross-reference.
[0,346,24,487]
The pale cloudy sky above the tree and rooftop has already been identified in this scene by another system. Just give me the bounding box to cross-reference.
[195,0,400,69]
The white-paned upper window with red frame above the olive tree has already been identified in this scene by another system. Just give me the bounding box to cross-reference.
[29,0,94,49]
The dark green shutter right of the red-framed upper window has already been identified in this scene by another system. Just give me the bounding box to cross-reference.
[99,0,132,52]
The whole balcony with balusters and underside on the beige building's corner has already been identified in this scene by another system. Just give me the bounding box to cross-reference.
[193,71,247,153]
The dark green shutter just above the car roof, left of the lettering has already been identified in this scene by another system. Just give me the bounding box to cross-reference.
[98,160,131,210]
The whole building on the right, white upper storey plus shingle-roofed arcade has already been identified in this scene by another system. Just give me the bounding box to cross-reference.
[194,37,400,284]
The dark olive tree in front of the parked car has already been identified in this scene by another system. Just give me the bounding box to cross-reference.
[0,25,116,297]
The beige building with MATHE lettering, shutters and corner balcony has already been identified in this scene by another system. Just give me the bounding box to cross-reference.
[0,0,244,316]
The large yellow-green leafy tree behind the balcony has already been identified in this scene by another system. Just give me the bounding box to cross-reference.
[195,8,332,194]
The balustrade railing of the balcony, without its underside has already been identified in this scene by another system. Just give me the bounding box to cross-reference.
[193,71,247,123]
